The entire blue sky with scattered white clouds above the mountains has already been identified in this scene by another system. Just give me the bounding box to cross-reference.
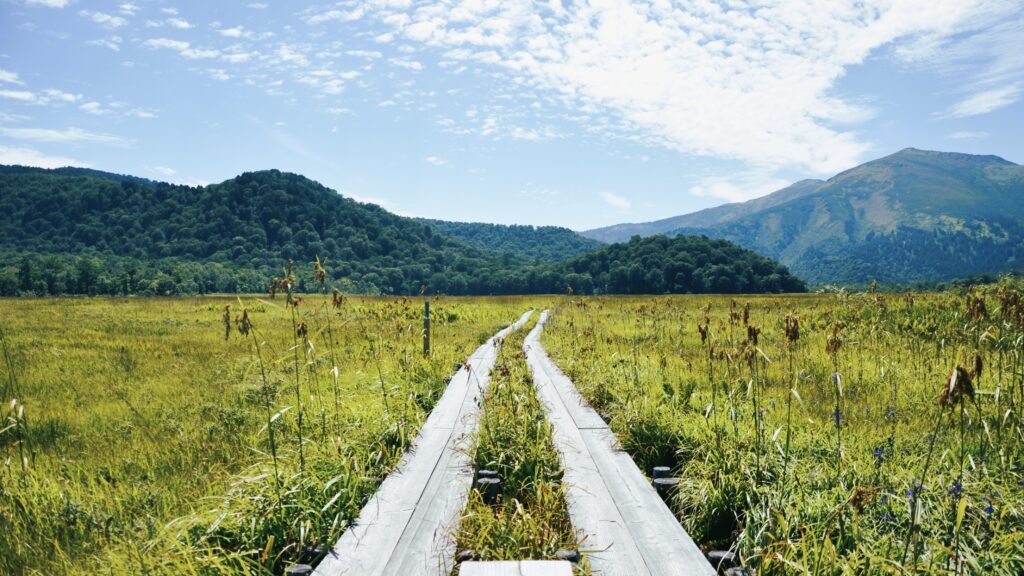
[0,0,1024,230]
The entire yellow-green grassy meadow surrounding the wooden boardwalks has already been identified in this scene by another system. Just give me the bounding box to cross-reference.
[0,268,1024,575]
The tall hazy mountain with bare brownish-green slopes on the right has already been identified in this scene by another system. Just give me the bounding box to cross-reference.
[583,149,1024,283]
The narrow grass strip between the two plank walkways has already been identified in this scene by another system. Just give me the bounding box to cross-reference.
[458,314,583,573]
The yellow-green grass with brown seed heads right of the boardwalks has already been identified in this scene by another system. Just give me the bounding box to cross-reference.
[544,283,1024,574]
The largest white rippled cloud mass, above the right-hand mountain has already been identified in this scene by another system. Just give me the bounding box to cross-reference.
[360,0,1020,173]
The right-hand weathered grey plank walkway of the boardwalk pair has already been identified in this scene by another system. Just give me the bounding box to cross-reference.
[523,311,715,576]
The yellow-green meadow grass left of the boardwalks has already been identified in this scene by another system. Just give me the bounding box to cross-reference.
[0,282,530,575]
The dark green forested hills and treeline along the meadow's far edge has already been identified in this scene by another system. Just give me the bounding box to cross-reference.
[0,163,804,295]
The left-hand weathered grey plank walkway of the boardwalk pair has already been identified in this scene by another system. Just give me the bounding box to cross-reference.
[314,312,532,576]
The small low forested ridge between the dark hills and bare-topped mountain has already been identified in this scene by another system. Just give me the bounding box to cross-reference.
[420,218,604,261]
